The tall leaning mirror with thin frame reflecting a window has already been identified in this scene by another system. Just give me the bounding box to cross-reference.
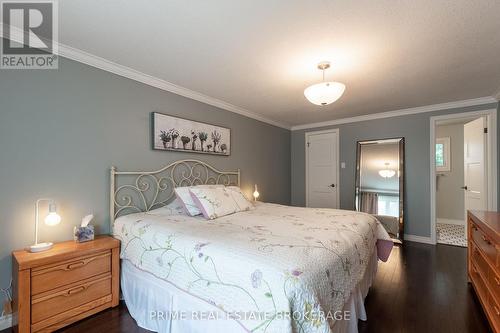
[355,138,405,244]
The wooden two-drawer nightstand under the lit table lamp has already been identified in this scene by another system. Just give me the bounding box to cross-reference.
[12,236,120,333]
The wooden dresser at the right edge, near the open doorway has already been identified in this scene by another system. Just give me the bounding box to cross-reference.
[467,211,500,332]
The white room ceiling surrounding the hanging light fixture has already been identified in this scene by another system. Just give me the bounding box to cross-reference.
[54,0,500,125]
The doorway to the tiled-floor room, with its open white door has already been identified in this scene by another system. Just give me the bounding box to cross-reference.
[431,110,497,247]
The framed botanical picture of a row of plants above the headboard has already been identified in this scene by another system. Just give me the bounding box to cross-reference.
[152,112,231,156]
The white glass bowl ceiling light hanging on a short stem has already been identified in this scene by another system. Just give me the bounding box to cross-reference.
[304,61,345,105]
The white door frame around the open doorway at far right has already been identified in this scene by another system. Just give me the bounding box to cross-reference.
[429,109,498,244]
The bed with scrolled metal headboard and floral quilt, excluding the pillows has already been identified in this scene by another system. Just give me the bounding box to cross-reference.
[110,160,392,333]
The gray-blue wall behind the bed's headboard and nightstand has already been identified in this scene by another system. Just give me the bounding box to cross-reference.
[0,59,290,308]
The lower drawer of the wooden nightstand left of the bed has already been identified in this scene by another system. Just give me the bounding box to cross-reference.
[31,274,111,324]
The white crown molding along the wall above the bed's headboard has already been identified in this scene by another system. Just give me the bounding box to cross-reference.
[0,22,290,130]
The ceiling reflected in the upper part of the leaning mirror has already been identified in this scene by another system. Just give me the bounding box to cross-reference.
[360,142,399,193]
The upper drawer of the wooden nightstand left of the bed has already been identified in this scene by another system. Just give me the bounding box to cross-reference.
[31,251,111,295]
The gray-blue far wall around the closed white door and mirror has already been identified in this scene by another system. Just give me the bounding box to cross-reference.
[291,103,500,237]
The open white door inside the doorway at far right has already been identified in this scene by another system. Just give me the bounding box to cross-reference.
[463,117,488,212]
